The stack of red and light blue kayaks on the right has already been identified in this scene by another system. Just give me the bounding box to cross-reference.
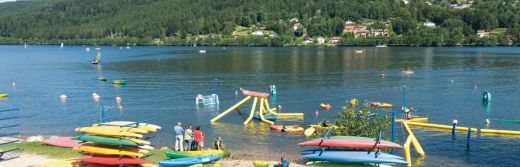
[298,136,407,164]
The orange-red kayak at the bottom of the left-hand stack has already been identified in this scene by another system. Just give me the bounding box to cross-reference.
[77,155,148,165]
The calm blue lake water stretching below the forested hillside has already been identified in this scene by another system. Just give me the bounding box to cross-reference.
[0,45,520,166]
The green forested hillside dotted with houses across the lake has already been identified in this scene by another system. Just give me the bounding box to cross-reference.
[0,0,520,46]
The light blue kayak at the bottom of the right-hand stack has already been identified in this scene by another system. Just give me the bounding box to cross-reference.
[303,151,408,164]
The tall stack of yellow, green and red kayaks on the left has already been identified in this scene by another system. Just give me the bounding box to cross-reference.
[72,121,161,166]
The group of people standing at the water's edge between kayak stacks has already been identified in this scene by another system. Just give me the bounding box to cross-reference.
[173,122,222,151]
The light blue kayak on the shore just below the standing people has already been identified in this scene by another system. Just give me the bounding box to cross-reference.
[159,155,222,167]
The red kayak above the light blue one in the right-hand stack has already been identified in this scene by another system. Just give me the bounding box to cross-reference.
[298,139,402,149]
